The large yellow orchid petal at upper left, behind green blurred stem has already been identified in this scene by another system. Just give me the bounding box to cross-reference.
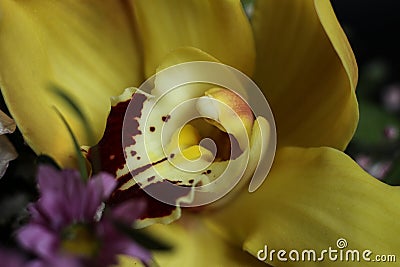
[0,0,143,166]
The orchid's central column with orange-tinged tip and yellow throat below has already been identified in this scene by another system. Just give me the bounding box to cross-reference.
[158,88,254,192]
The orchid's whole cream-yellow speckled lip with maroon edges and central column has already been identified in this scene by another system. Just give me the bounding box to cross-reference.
[87,58,276,227]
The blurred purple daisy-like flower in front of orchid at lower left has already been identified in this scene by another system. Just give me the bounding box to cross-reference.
[17,166,151,267]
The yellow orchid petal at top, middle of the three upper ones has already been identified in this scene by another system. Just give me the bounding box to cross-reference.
[132,0,255,76]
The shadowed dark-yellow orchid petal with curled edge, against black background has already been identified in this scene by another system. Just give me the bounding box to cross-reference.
[252,0,358,150]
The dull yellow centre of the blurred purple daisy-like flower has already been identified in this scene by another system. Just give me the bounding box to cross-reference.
[61,223,100,258]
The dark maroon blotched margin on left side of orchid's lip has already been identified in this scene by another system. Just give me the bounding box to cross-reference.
[87,93,191,222]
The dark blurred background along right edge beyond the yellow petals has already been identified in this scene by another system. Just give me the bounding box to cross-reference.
[331,0,400,185]
